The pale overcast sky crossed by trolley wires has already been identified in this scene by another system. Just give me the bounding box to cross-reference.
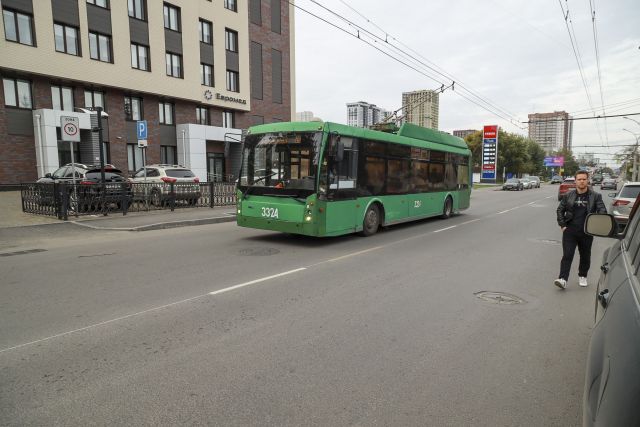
[294,0,640,165]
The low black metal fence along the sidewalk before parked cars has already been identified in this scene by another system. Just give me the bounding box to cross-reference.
[20,182,236,220]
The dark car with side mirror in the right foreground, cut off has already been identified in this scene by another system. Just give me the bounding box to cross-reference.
[582,199,640,427]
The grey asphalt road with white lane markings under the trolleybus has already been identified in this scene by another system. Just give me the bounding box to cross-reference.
[0,186,612,426]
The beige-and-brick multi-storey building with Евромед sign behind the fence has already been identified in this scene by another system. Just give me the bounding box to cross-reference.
[0,0,295,184]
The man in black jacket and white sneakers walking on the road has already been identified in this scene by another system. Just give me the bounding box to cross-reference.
[553,171,607,289]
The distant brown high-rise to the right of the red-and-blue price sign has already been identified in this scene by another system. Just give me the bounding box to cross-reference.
[529,111,573,154]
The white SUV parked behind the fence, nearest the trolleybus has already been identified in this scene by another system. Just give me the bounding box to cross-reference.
[130,164,202,206]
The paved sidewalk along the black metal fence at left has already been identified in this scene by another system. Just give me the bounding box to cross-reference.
[0,191,236,231]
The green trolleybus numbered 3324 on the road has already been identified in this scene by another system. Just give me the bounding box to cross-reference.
[237,122,472,236]
